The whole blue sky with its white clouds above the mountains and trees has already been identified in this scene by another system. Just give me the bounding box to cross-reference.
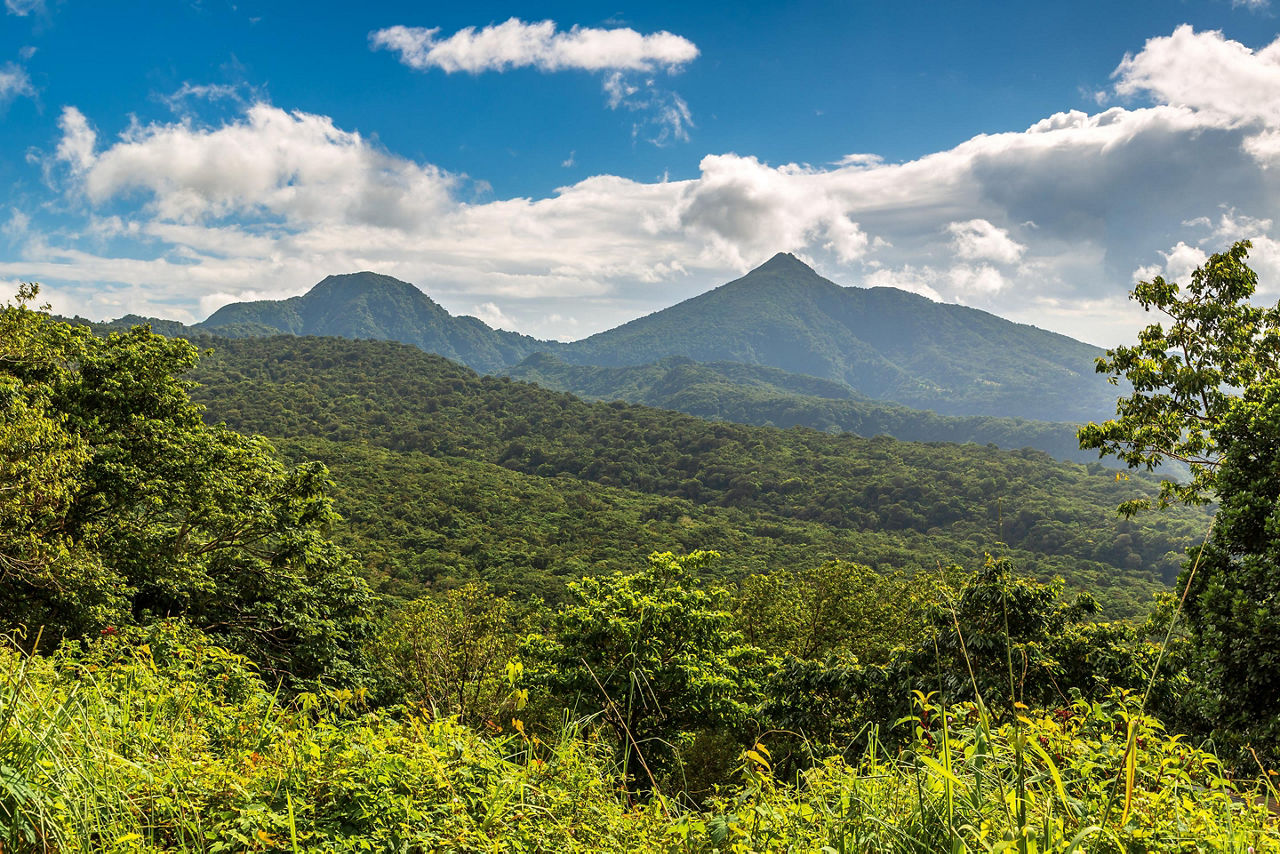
[0,0,1280,344]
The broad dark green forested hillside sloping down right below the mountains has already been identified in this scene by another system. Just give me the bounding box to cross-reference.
[192,337,1206,613]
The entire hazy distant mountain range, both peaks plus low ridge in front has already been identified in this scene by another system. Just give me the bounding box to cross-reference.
[94,254,1117,458]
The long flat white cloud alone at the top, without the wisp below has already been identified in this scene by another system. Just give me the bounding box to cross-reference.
[369,18,698,74]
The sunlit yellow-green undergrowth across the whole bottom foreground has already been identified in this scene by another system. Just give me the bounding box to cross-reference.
[0,624,1280,854]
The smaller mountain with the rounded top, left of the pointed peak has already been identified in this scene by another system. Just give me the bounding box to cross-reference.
[193,273,556,371]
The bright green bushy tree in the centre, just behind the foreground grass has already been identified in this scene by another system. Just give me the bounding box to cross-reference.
[525,552,763,786]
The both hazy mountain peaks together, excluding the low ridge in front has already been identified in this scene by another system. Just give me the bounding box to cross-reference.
[97,252,1116,423]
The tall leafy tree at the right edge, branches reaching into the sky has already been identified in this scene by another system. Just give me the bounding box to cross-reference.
[1080,241,1280,758]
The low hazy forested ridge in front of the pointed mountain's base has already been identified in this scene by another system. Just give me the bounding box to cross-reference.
[504,353,1097,462]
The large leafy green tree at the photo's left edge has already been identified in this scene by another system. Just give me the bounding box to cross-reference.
[0,287,371,680]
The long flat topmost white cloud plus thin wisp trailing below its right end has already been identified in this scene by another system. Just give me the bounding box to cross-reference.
[369,18,698,146]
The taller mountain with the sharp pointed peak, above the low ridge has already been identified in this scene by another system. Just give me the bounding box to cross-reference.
[557,254,1116,421]
